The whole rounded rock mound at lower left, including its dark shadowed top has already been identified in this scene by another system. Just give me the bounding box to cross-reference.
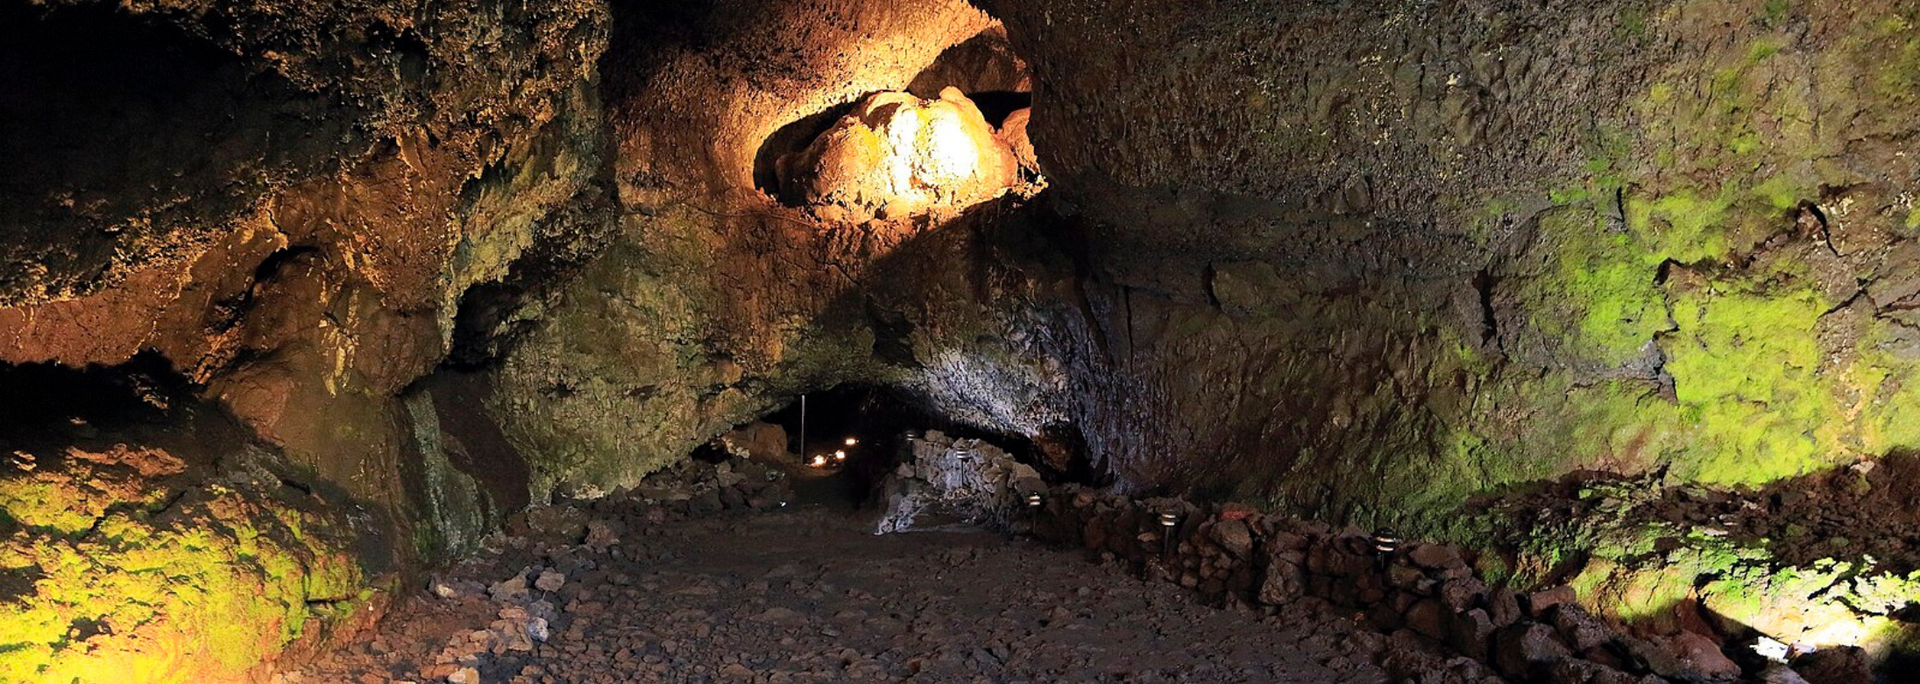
[0,369,397,684]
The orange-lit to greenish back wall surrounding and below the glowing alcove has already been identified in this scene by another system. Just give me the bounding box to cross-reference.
[492,0,1082,498]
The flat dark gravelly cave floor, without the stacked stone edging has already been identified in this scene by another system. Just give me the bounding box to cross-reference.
[278,505,1386,684]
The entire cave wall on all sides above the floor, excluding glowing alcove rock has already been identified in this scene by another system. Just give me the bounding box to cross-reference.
[0,0,1920,682]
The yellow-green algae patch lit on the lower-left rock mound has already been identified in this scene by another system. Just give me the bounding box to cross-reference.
[0,450,365,684]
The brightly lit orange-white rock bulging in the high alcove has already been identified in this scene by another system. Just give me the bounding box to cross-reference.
[785,88,1018,221]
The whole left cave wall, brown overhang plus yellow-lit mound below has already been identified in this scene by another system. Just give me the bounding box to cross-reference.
[0,2,609,682]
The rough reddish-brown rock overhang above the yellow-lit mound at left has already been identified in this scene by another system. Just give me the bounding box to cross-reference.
[0,2,607,503]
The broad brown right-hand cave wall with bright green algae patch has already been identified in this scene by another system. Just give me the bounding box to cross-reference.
[983,0,1920,530]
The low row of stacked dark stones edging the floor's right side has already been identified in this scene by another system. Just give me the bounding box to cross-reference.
[1016,484,1774,684]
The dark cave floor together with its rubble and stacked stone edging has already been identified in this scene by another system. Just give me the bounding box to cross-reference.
[288,432,1870,684]
